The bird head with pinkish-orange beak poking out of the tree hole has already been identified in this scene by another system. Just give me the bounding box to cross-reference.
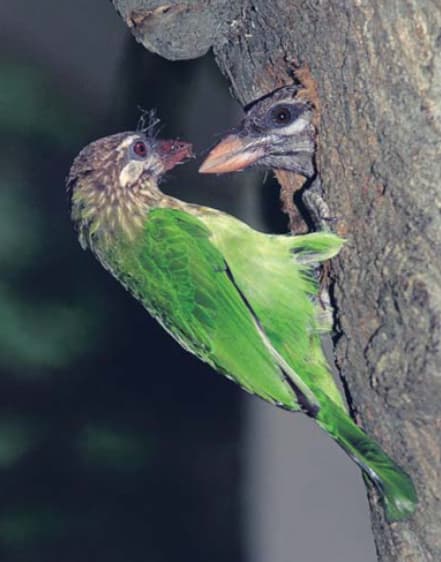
[199,85,315,177]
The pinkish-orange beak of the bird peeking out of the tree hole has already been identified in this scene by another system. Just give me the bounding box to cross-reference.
[199,135,265,174]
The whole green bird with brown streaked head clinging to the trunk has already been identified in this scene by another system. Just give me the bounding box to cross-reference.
[67,120,416,520]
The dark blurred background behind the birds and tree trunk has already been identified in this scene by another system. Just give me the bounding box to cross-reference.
[0,0,374,562]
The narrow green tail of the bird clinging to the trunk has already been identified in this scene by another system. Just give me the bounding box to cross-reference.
[316,401,418,521]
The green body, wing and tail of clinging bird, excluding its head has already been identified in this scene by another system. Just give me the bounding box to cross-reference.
[81,197,416,521]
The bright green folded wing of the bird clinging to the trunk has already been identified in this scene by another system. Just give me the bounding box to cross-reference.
[111,209,313,410]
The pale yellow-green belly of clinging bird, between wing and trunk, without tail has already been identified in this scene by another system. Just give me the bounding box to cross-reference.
[202,212,345,408]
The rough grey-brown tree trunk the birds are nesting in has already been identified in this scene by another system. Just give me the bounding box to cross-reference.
[114,0,441,562]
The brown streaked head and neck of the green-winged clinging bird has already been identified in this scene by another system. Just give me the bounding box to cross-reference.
[66,131,192,248]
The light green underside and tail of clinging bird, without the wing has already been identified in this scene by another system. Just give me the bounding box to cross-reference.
[201,213,417,521]
